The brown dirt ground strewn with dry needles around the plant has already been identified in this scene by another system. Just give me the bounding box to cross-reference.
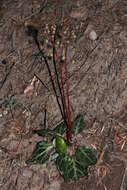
[0,0,127,190]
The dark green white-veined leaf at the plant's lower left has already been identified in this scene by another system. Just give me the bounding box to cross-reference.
[27,141,54,164]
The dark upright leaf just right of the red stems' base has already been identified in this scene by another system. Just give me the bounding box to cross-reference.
[72,115,85,135]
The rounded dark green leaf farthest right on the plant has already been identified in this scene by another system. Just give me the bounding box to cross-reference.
[75,146,97,167]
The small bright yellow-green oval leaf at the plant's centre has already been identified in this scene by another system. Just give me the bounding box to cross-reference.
[55,135,67,155]
